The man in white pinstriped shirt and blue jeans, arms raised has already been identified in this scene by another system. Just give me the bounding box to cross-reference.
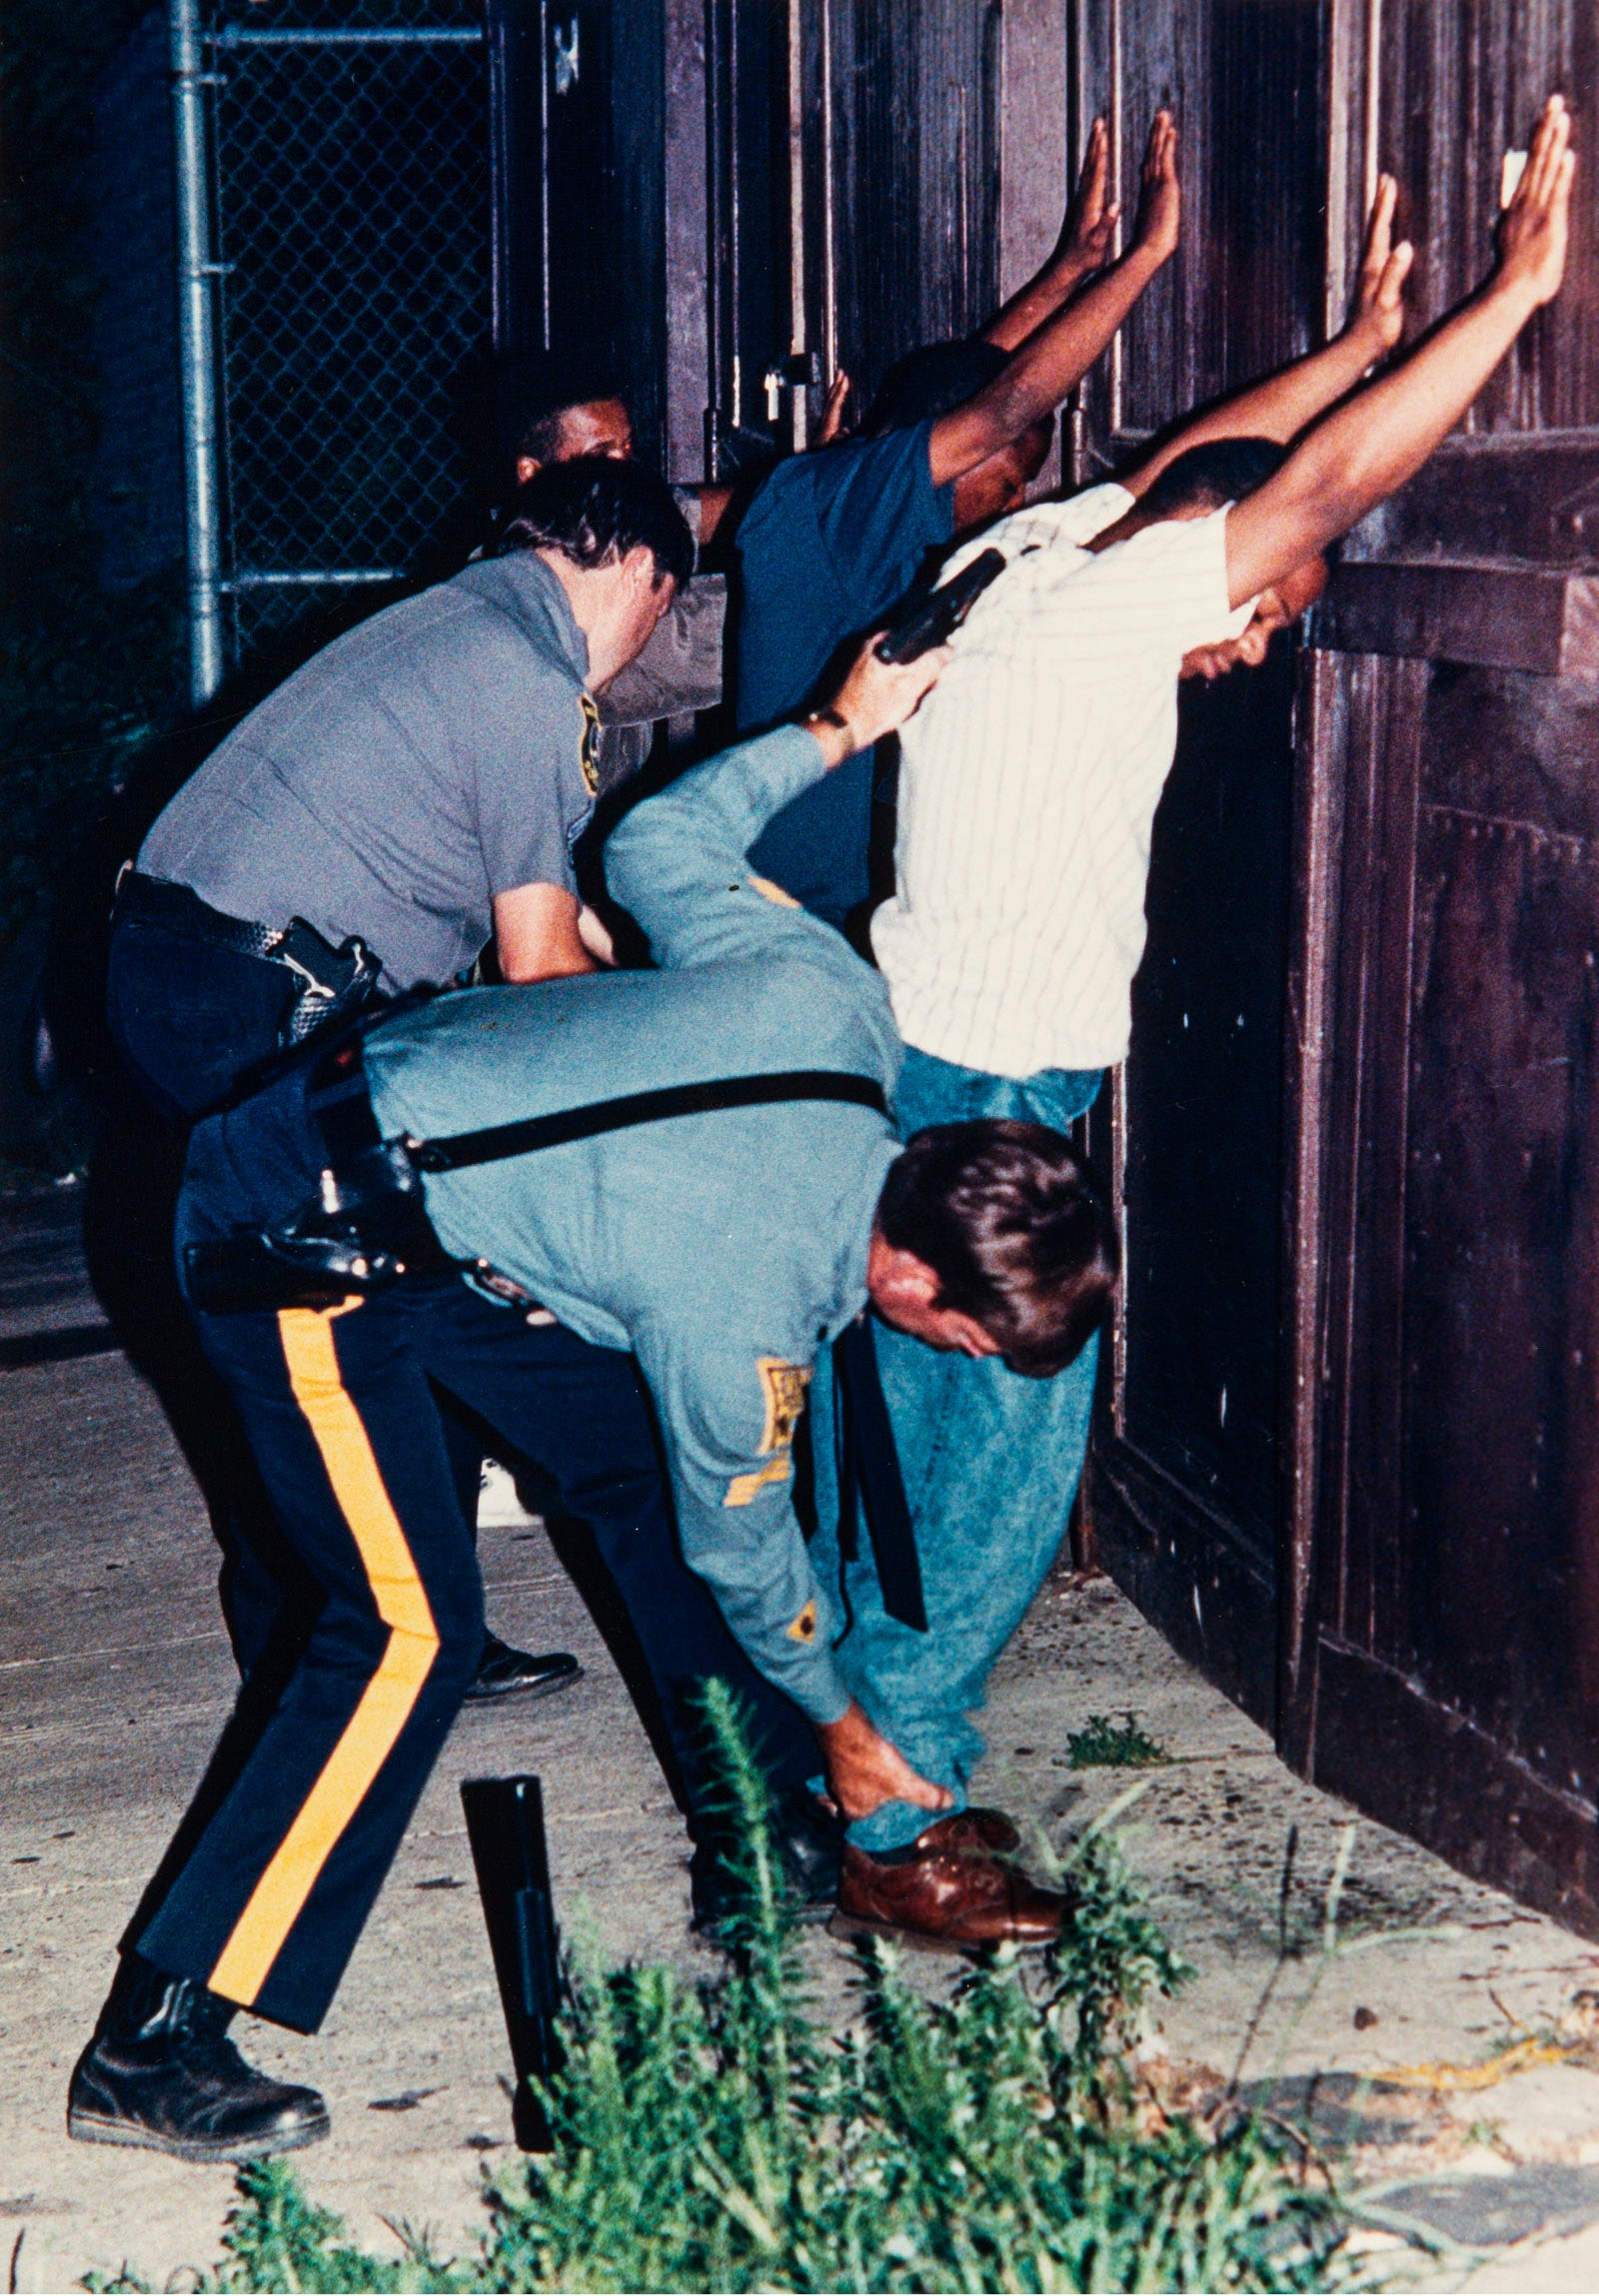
[813,97,1571,1889]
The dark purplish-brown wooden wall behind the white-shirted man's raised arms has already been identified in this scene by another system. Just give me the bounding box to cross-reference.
[1084,0,1599,1933]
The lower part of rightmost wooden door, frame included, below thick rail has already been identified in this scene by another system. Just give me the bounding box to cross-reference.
[1286,613,1599,1933]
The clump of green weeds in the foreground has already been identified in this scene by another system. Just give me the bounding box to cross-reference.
[81,1690,1396,2291]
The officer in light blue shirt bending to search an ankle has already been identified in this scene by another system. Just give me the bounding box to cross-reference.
[69,633,1114,2158]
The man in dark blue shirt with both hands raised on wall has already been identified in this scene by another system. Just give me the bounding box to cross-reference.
[736,113,1178,925]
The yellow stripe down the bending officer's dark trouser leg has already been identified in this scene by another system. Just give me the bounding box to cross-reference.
[209,1300,439,2006]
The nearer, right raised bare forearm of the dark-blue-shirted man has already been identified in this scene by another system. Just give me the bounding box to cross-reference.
[930,113,1181,487]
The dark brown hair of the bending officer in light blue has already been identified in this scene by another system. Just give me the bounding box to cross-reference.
[877,1118,1121,1380]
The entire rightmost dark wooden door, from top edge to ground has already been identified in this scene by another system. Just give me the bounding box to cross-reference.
[1282,0,1599,1935]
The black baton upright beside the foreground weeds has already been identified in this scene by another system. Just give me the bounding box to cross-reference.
[462,1777,561,2151]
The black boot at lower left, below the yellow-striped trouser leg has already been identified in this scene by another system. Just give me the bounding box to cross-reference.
[67,1954,329,2160]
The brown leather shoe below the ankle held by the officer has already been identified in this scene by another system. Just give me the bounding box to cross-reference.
[833,1809,1068,1954]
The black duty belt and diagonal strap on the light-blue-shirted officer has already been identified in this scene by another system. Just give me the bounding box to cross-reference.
[184,1026,889,1313]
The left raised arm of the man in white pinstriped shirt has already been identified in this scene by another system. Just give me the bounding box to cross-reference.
[1119,175,1415,494]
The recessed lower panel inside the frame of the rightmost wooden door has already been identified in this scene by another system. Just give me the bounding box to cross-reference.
[1383,665,1599,1797]
